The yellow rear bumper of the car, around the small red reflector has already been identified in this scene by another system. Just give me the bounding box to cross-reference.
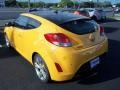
[48,38,108,81]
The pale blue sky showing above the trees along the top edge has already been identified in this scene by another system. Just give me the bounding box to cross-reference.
[17,0,120,3]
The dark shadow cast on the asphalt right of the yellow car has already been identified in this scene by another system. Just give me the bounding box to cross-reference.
[77,40,120,85]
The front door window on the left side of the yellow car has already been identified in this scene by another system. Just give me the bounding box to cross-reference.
[15,16,28,29]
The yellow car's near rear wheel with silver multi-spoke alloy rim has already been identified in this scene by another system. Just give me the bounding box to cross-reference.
[33,54,51,83]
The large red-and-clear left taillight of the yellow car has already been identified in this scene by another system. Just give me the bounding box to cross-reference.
[44,33,72,47]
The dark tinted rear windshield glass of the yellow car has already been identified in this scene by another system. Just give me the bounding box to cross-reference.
[60,20,97,35]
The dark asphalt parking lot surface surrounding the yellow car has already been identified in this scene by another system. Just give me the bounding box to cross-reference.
[0,20,120,90]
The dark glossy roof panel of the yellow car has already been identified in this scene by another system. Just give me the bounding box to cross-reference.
[30,10,89,24]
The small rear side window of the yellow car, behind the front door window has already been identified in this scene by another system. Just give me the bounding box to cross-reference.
[27,18,40,29]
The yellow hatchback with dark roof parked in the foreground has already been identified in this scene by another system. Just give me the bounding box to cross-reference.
[4,10,108,82]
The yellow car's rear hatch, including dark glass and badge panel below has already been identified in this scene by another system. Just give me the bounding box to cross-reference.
[60,19,104,48]
